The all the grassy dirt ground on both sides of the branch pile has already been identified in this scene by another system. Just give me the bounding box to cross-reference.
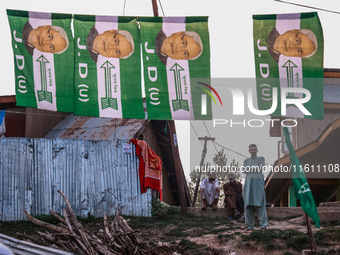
[0,213,340,255]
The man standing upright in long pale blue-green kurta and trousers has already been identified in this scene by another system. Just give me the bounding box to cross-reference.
[242,144,268,230]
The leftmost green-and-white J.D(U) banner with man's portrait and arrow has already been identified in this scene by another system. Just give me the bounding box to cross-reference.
[7,10,74,112]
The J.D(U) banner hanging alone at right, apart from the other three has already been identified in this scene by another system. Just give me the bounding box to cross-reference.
[253,12,324,119]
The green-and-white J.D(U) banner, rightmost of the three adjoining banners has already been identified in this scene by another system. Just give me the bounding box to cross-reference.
[139,17,212,120]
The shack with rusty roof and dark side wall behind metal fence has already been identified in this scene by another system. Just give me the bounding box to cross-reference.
[45,115,189,205]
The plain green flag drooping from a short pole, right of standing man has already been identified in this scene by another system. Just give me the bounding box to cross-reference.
[283,127,320,228]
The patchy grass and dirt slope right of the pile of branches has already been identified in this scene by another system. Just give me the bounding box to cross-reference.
[127,215,340,255]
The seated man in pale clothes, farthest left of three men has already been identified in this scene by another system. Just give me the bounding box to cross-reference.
[199,172,220,210]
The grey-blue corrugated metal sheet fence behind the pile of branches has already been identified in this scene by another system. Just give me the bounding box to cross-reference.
[0,138,151,221]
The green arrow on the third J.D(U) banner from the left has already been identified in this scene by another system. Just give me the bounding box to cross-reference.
[170,63,189,112]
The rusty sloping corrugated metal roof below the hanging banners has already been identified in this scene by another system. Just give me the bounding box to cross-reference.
[45,115,148,141]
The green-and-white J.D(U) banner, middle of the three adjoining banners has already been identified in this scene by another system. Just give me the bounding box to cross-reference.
[74,15,145,119]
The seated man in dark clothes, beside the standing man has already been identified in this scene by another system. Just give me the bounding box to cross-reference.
[223,172,244,220]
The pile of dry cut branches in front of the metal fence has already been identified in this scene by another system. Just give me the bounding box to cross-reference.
[25,191,160,255]
